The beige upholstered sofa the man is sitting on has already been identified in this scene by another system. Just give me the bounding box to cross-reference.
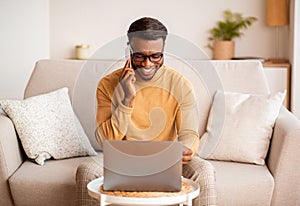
[0,60,300,206]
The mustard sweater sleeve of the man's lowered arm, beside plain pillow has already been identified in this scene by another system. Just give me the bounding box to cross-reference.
[176,80,200,155]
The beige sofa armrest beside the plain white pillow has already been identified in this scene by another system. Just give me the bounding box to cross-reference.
[267,107,300,206]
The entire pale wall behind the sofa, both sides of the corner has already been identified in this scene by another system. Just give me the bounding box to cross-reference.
[0,0,292,104]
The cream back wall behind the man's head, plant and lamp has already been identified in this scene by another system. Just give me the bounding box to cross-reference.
[50,0,288,58]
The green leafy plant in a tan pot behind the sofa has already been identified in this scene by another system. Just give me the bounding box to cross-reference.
[208,10,257,59]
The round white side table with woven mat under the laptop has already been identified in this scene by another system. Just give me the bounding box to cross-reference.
[87,177,200,206]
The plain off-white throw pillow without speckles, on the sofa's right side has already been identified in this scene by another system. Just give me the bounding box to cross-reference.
[199,91,286,165]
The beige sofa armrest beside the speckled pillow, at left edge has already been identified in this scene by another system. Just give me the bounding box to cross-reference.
[0,108,23,205]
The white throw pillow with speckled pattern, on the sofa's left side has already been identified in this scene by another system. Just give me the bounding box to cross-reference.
[0,88,97,165]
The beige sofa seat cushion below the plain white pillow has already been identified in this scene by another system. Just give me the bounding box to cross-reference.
[209,161,274,206]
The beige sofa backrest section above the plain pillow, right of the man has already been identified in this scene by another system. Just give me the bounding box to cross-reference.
[166,59,270,136]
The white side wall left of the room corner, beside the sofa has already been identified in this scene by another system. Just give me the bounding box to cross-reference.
[0,0,49,99]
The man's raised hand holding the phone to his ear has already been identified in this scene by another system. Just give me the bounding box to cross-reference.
[120,59,136,107]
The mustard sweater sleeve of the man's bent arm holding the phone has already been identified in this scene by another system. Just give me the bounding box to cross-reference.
[95,72,133,147]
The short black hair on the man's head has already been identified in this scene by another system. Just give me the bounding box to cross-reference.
[127,17,168,42]
